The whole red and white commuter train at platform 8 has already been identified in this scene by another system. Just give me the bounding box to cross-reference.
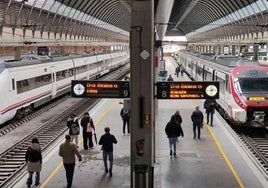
[175,52,268,127]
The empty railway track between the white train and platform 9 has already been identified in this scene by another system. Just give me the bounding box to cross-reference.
[0,66,129,187]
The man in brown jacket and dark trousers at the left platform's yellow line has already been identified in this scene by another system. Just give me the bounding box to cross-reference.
[59,135,82,188]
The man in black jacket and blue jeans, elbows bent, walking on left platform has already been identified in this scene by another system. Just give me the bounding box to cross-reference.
[99,127,117,176]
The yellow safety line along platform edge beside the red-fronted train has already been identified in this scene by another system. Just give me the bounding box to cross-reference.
[192,101,245,188]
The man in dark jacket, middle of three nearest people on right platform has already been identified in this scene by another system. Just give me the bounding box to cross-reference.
[191,106,204,139]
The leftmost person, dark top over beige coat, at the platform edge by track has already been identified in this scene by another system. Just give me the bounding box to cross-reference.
[25,138,42,188]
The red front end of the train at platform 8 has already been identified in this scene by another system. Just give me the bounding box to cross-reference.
[231,66,268,127]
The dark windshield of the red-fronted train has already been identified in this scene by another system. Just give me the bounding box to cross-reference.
[235,78,268,93]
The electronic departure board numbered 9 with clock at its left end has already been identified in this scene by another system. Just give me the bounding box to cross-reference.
[71,80,130,98]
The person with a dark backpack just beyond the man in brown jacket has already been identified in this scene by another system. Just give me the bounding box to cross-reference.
[67,114,80,148]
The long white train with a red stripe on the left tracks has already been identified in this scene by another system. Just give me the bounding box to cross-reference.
[0,51,129,124]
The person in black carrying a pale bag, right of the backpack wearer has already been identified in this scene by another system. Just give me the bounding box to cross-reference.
[81,112,95,150]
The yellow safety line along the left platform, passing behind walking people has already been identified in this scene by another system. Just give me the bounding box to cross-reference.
[40,100,117,188]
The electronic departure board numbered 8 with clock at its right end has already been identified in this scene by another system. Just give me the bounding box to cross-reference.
[156,81,219,99]
